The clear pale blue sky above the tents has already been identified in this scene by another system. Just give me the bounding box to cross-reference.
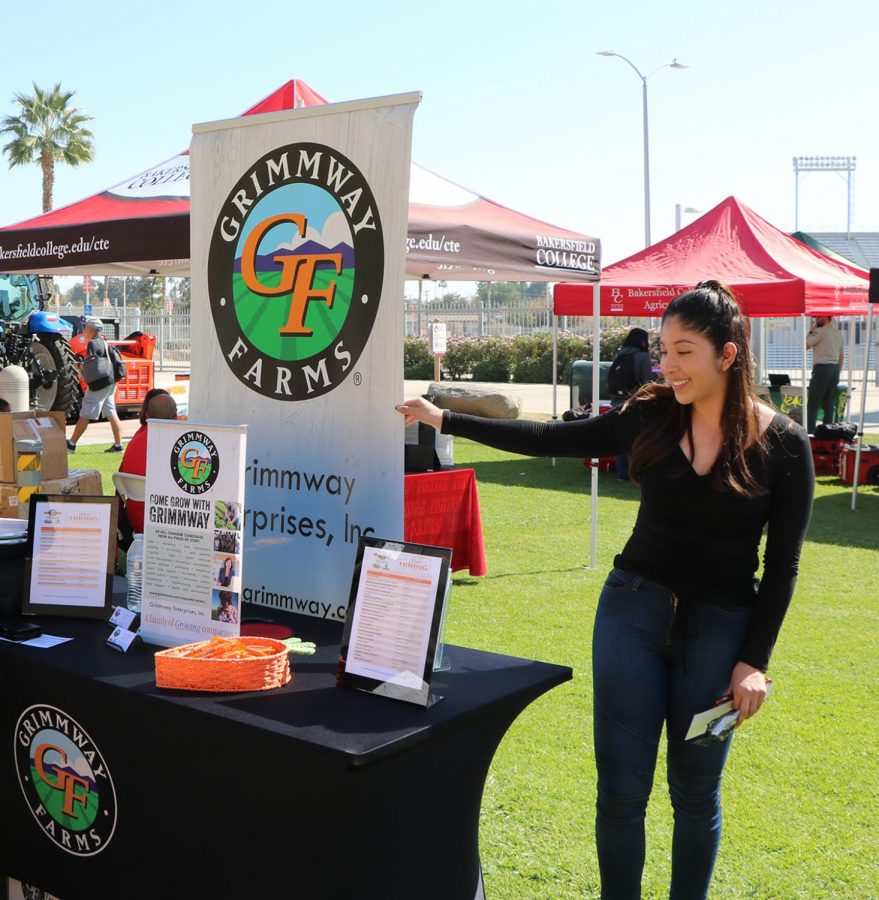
[0,0,879,278]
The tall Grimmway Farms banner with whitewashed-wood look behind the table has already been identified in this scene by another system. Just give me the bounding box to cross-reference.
[189,94,420,619]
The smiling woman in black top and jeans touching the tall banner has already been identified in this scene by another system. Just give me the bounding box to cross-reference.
[398,281,814,898]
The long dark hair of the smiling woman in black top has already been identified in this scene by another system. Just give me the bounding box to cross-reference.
[629,281,765,497]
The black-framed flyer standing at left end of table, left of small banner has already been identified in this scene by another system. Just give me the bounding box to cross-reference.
[21,494,117,619]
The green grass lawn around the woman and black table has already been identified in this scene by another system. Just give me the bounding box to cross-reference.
[77,434,879,900]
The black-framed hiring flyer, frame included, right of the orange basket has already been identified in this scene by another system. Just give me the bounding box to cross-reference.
[339,537,452,706]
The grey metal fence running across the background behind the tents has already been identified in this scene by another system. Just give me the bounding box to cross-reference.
[61,301,879,384]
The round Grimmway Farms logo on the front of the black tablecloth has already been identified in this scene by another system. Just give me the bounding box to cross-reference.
[15,704,116,856]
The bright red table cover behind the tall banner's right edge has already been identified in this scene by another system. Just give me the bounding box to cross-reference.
[403,469,487,575]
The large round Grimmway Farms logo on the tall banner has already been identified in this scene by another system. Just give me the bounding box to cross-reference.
[208,143,384,400]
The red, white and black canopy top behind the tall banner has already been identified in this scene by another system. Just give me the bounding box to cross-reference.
[0,80,599,281]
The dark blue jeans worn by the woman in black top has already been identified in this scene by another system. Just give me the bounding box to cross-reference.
[592,569,752,900]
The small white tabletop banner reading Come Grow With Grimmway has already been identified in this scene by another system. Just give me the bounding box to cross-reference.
[140,419,247,647]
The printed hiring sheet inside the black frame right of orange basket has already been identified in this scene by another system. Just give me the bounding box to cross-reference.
[345,546,443,691]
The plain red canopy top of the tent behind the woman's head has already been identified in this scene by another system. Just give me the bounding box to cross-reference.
[554,197,869,316]
